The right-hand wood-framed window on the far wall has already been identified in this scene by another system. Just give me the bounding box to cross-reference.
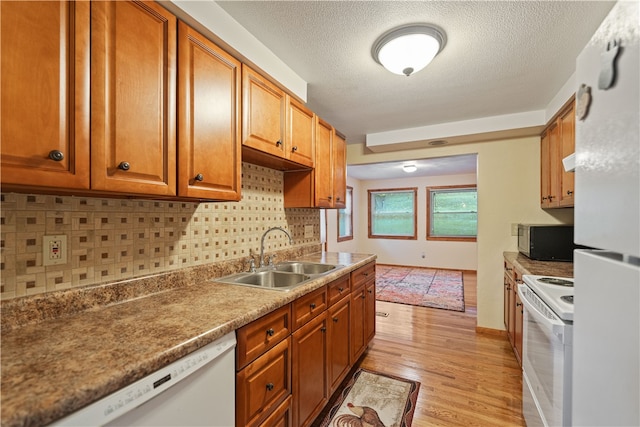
[427,185,478,242]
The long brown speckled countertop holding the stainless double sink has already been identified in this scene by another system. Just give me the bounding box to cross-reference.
[0,252,375,427]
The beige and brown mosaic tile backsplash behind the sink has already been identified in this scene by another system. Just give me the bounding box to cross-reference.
[0,163,320,299]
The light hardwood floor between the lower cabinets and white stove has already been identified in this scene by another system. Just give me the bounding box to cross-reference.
[360,272,525,427]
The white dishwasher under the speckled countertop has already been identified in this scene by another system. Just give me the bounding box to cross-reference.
[50,332,236,427]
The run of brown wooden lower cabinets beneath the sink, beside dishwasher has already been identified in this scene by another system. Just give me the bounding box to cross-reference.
[236,262,375,427]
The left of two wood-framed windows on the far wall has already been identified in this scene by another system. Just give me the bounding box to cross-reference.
[368,188,418,240]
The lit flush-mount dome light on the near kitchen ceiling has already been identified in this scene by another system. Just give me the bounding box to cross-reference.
[371,24,447,76]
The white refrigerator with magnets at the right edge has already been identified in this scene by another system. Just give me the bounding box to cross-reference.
[572,1,640,426]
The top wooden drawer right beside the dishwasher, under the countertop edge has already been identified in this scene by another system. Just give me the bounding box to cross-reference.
[236,305,291,370]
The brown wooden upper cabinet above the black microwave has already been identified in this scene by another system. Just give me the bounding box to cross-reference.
[540,97,575,209]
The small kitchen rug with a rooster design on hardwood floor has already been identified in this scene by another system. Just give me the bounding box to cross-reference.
[319,369,420,427]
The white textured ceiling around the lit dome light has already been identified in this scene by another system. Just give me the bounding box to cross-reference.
[217,1,613,177]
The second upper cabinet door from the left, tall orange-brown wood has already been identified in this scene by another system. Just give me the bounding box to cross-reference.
[91,1,176,196]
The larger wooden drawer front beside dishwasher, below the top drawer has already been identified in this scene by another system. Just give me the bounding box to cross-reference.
[236,338,291,427]
